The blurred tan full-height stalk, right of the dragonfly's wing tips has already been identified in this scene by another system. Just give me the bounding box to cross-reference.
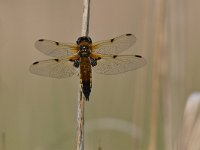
[148,0,165,150]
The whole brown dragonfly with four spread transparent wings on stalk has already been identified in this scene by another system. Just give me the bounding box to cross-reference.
[29,34,146,101]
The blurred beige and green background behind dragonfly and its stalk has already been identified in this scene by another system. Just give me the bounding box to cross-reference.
[0,0,200,150]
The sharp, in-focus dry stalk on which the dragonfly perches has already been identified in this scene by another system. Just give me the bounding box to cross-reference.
[77,0,90,150]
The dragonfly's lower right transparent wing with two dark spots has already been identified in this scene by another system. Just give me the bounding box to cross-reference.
[93,55,146,75]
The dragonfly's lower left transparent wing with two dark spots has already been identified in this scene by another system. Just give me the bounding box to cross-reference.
[29,58,78,78]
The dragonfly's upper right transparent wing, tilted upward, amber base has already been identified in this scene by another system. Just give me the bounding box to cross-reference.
[92,34,136,54]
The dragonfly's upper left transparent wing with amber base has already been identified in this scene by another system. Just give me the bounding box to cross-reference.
[35,39,77,57]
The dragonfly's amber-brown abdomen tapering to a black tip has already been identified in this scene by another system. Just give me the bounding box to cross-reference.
[80,57,92,100]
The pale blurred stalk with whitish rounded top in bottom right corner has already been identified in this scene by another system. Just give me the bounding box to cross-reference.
[174,93,200,150]
